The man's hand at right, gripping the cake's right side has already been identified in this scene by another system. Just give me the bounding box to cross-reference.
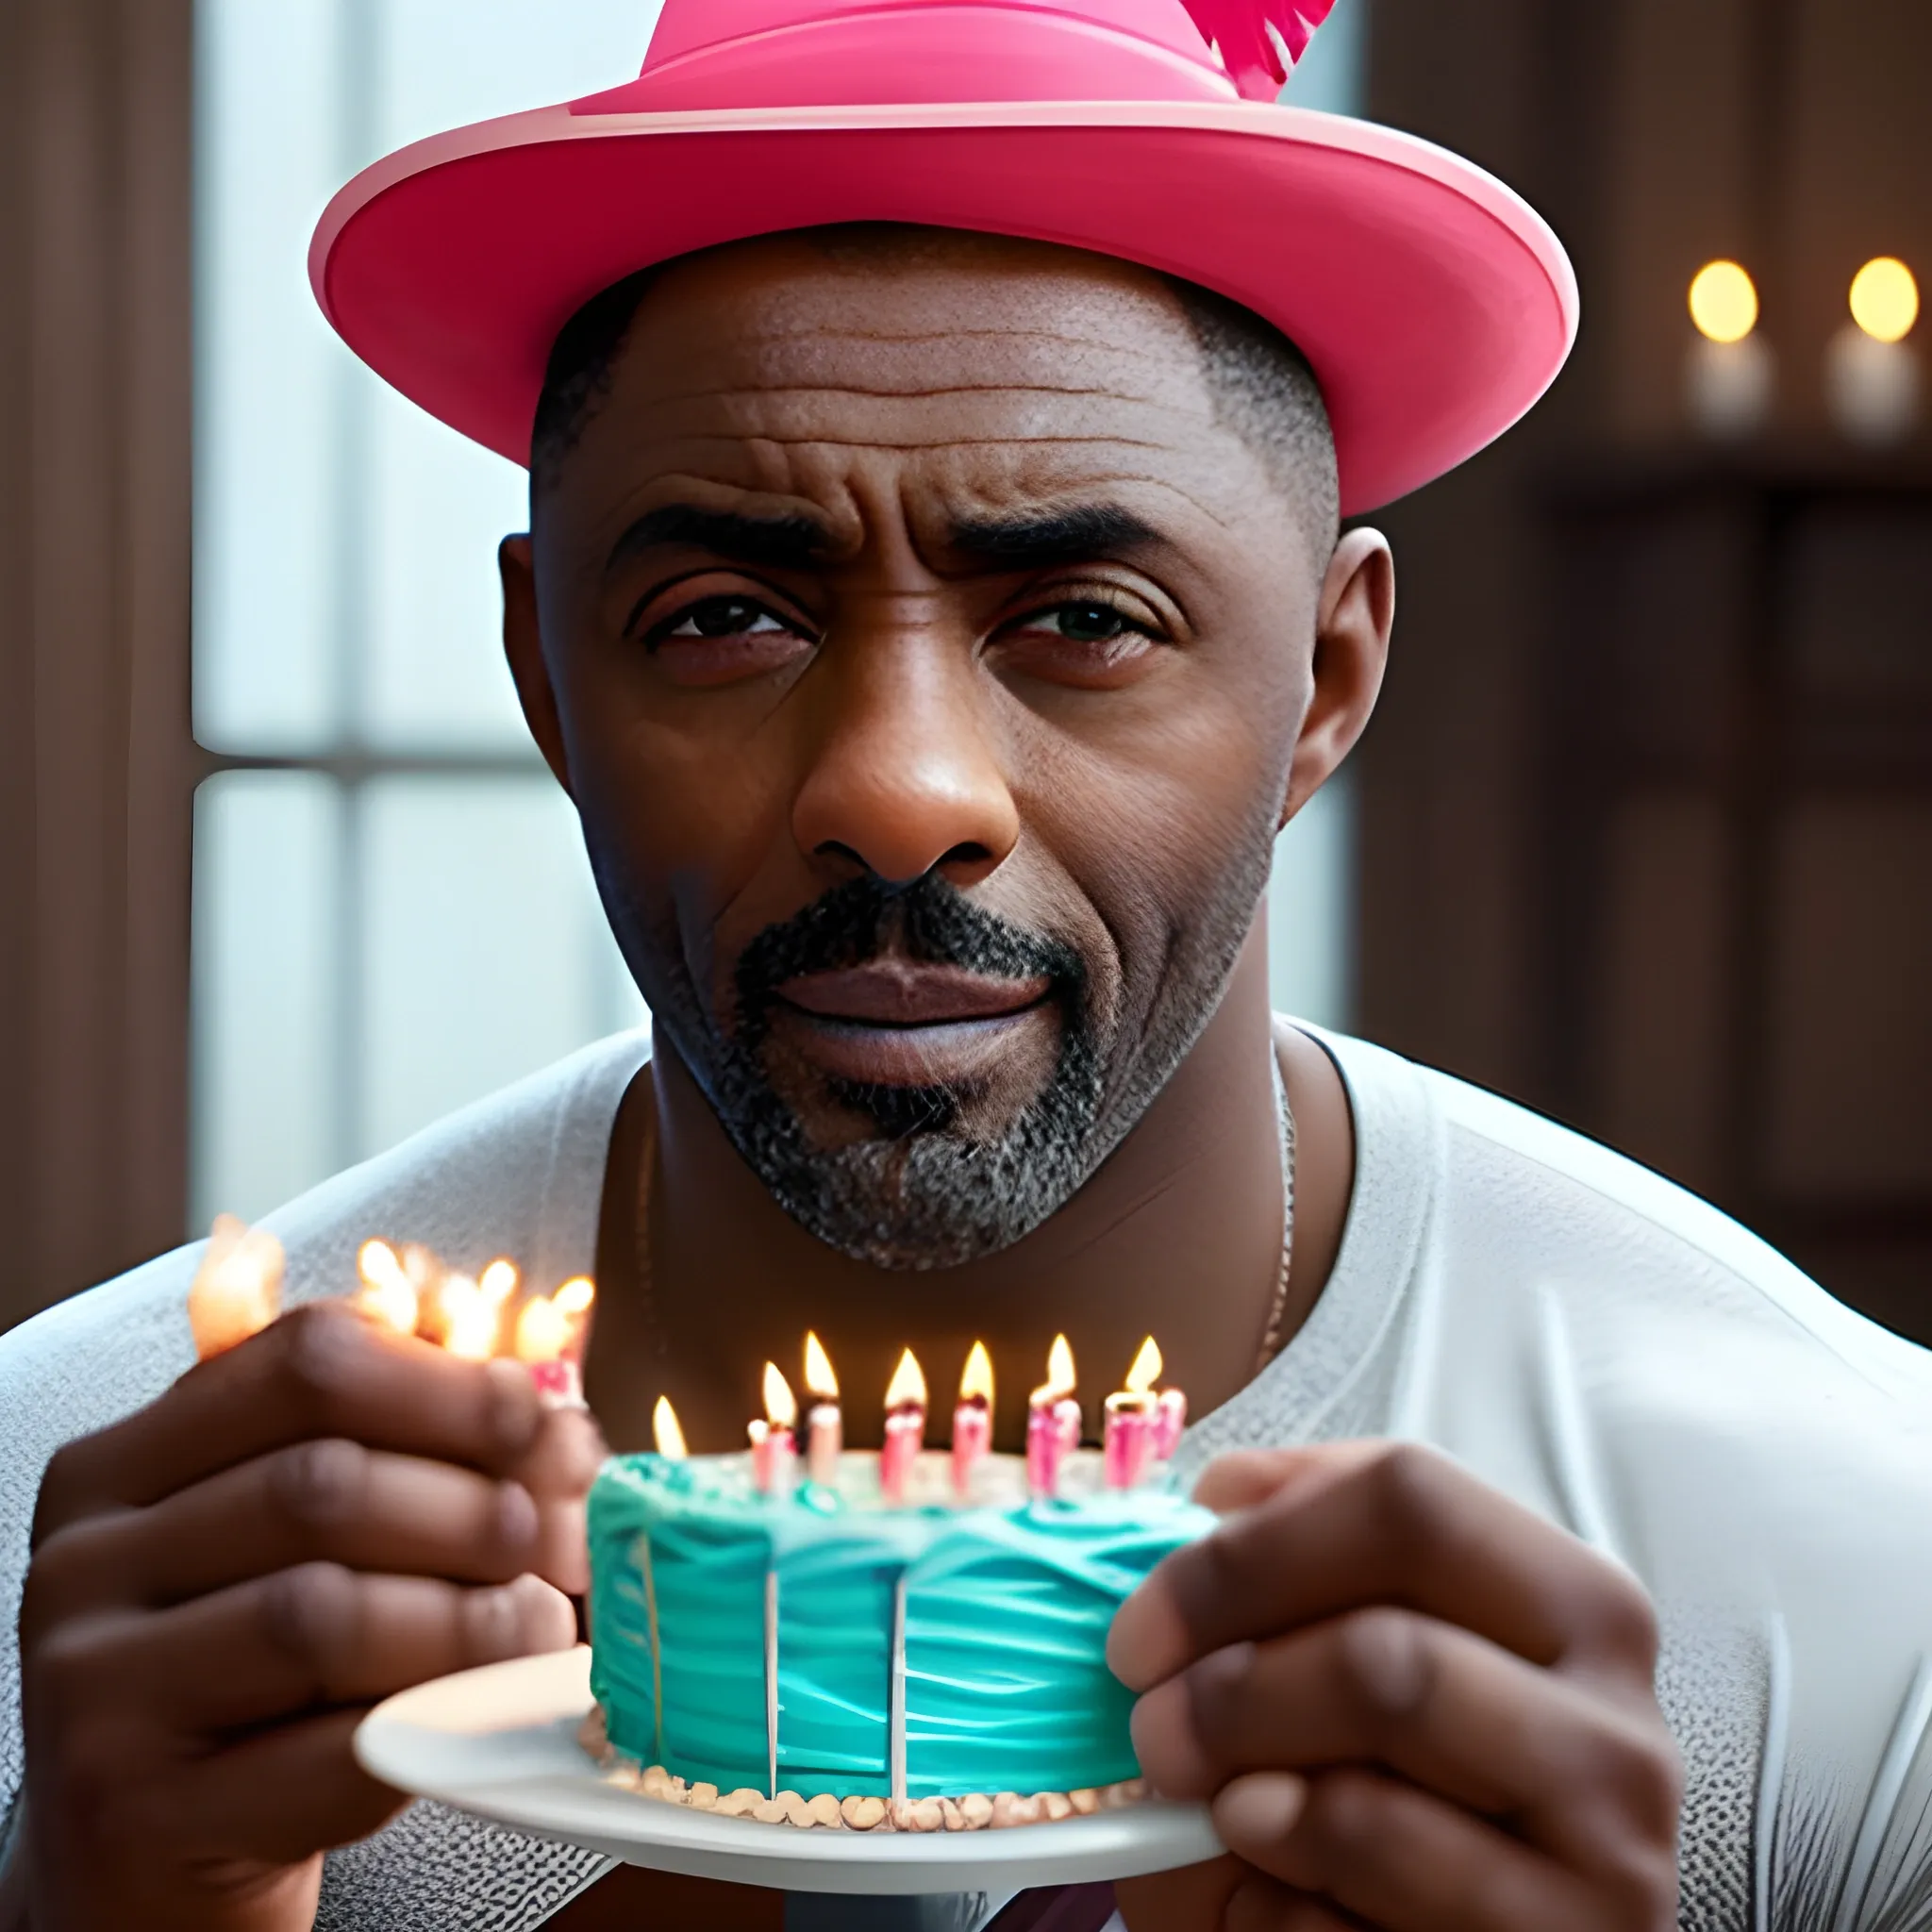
[1109,1443,1681,1932]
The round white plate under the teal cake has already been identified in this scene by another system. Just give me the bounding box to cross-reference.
[356,1646,1221,1893]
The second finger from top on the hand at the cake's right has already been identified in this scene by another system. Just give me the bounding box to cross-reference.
[1134,1609,1679,1866]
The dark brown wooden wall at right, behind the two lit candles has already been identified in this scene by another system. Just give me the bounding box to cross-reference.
[1360,0,1932,1339]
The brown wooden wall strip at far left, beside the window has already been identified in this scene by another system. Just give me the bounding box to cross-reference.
[0,0,193,1327]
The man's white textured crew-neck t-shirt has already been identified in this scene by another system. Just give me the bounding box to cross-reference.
[0,1030,1932,1932]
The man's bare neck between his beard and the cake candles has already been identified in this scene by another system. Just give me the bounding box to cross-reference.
[588,919,1325,1451]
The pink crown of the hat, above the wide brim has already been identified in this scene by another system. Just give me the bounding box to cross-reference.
[574,0,1333,114]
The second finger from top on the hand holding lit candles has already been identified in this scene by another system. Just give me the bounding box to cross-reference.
[22,1438,539,1642]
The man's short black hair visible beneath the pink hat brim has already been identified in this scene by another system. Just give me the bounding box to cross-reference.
[529,223,1341,551]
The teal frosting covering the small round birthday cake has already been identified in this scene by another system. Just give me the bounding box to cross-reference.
[590,1455,1215,1797]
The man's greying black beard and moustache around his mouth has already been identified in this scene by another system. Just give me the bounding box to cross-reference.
[640,824,1274,1270]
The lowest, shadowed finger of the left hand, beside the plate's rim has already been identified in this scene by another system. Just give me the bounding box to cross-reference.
[166,1707,409,1866]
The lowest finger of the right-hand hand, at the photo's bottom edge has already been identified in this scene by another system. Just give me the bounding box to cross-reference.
[1213,1770,1675,1932]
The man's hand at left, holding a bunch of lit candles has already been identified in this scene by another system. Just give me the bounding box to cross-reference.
[19,1306,601,1932]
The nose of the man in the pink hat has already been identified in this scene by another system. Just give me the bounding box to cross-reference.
[792,632,1020,887]
